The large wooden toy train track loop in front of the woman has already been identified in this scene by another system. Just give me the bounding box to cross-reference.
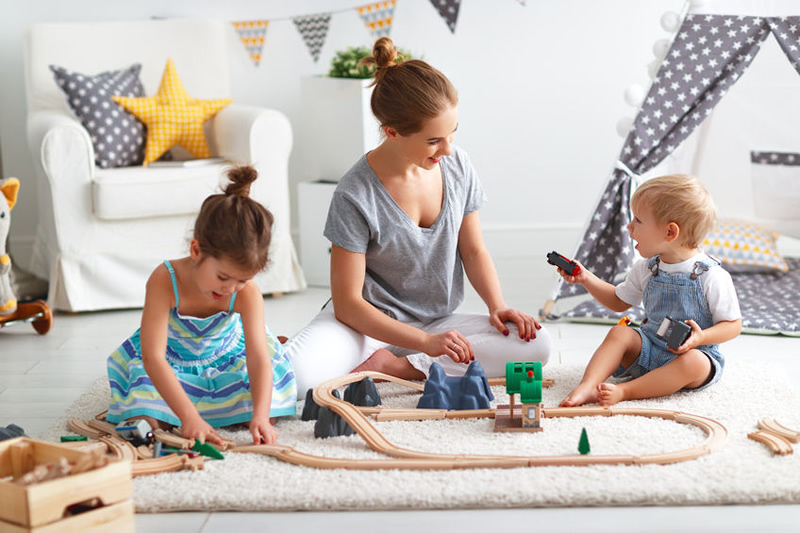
[234,372,728,470]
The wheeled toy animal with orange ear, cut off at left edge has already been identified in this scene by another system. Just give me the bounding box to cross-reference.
[0,178,53,335]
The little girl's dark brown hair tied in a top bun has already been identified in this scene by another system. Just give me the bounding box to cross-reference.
[194,166,274,272]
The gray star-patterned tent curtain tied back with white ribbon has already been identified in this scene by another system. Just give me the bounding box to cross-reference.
[557,14,800,298]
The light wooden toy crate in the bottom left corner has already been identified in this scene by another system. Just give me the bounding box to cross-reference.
[0,437,134,533]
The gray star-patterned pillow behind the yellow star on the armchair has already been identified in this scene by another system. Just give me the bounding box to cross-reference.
[50,63,147,168]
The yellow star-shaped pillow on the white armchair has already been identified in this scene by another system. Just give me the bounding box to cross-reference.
[111,59,233,166]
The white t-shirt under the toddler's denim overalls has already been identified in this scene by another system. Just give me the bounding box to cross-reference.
[616,253,742,324]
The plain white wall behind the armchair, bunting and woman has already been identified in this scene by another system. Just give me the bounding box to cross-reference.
[0,0,684,265]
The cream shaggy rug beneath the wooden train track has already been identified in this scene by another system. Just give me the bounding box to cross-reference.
[44,363,800,512]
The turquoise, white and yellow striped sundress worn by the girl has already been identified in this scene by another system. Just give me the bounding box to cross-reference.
[107,261,297,427]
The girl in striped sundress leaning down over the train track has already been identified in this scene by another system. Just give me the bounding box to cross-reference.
[107,167,296,444]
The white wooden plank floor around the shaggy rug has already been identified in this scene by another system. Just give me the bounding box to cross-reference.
[0,259,800,533]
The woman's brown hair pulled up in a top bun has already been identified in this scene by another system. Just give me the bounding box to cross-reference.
[359,37,458,137]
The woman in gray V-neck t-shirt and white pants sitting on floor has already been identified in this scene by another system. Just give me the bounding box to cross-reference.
[287,37,550,394]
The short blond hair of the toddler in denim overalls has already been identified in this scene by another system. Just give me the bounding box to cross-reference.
[631,174,717,247]
